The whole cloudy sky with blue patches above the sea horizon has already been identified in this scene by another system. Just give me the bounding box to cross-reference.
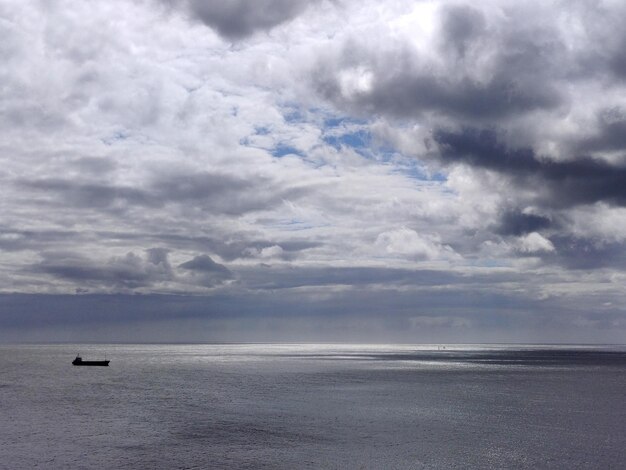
[0,0,626,343]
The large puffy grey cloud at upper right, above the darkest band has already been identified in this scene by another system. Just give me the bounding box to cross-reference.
[314,6,567,121]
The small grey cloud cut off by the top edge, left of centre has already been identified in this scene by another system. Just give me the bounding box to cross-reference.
[163,0,317,40]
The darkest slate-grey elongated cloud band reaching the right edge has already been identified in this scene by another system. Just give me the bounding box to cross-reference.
[432,128,626,207]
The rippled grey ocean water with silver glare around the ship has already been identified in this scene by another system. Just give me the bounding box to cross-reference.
[0,344,626,469]
